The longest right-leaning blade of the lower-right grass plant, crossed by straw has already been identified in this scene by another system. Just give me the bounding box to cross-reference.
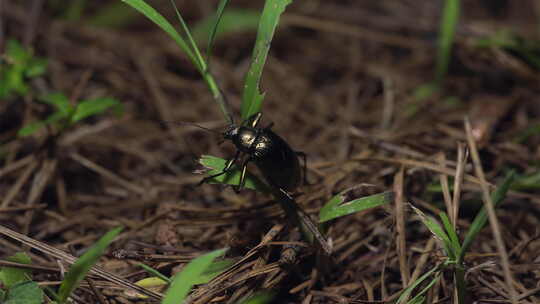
[458,171,515,263]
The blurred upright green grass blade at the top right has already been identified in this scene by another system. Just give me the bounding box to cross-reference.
[435,0,460,83]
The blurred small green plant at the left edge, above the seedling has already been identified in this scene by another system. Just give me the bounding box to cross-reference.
[0,39,47,99]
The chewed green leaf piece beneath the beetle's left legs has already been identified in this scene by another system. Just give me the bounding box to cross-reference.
[199,155,270,193]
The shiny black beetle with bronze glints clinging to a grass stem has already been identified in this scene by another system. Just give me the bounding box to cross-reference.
[199,112,306,192]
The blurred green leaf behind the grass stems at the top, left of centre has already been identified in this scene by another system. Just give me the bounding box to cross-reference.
[192,8,261,45]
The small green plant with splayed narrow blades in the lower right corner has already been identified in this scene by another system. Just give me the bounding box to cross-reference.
[396,172,515,304]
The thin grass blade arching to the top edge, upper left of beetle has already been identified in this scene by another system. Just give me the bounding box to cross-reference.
[122,0,198,67]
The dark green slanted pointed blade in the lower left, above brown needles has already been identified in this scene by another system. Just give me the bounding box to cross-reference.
[58,227,122,303]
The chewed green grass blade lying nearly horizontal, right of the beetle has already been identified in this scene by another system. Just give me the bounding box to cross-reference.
[319,188,394,223]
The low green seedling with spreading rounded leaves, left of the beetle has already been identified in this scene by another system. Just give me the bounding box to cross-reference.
[18,93,122,136]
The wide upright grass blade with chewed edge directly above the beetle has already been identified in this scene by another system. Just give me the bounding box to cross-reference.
[240,0,292,120]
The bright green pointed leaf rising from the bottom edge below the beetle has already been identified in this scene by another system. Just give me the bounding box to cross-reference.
[161,249,227,304]
